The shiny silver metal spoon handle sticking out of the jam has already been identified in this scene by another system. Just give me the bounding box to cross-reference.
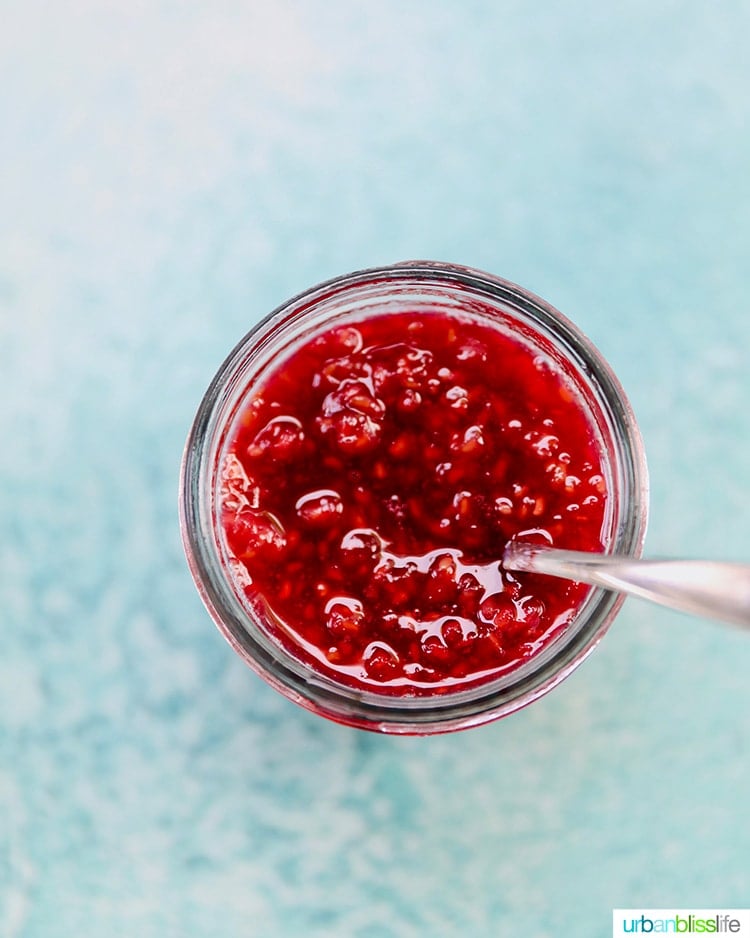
[503,541,750,628]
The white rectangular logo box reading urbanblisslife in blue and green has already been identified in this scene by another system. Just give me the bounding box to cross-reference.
[612,909,750,938]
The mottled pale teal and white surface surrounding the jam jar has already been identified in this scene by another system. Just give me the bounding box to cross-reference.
[0,0,750,938]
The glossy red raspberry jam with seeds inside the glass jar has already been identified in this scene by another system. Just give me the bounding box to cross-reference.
[219,311,605,696]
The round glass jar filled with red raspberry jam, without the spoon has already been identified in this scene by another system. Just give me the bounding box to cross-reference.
[180,262,646,733]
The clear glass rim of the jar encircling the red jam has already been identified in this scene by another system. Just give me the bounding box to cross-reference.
[180,261,648,734]
